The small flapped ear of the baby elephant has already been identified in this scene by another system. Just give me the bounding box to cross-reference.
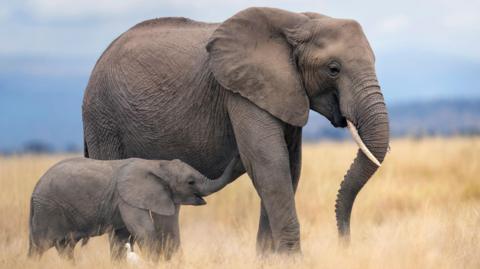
[115,161,175,216]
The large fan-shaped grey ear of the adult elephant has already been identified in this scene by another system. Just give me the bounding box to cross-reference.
[207,8,309,126]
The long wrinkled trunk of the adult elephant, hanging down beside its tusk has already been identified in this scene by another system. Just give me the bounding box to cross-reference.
[335,75,389,242]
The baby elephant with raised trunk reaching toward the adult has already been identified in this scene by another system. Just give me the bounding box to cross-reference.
[28,158,239,261]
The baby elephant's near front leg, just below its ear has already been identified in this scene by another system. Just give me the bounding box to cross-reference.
[119,202,161,262]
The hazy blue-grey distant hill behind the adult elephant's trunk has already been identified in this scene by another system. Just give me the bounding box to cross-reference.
[304,99,480,140]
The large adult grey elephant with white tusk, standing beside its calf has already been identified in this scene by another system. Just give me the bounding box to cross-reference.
[83,8,389,252]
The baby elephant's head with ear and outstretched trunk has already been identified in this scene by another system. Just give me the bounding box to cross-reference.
[116,156,240,216]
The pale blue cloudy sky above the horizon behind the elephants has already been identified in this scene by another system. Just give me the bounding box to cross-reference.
[0,0,480,149]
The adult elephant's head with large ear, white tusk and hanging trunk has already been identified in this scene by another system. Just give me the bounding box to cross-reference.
[207,8,389,238]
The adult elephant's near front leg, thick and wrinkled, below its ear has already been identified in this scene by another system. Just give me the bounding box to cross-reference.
[229,95,300,252]
